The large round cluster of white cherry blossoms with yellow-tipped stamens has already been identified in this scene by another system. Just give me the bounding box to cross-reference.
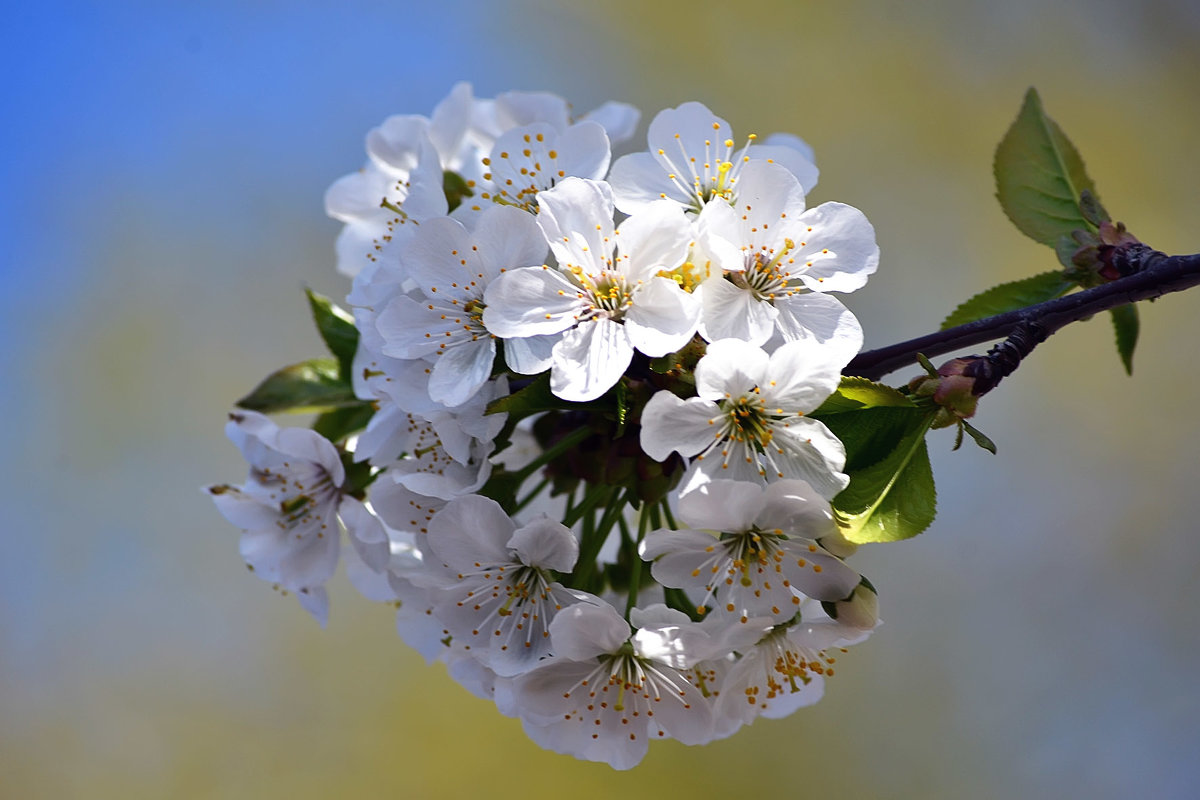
[208,84,878,769]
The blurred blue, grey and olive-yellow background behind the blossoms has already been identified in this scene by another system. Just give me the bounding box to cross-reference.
[0,0,1200,800]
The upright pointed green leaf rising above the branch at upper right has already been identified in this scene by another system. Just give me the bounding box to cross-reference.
[994,89,1099,247]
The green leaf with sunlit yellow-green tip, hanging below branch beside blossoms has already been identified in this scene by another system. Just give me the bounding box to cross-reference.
[833,411,937,545]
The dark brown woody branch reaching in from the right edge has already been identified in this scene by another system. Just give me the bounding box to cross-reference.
[842,243,1200,380]
